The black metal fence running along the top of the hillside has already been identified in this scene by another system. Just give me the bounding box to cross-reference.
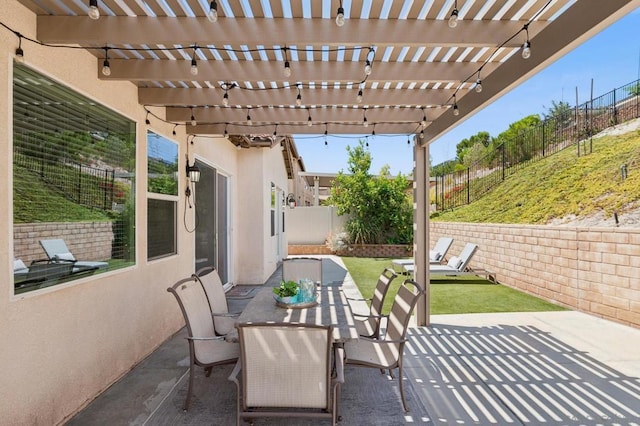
[435,80,640,210]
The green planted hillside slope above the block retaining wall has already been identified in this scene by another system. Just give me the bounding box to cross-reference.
[431,120,640,227]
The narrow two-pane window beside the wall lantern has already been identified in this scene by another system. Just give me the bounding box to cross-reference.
[147,132,178,259]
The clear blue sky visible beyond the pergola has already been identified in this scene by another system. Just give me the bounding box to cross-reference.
[294,8,640,174]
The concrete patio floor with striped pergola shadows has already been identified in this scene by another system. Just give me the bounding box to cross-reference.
[67,257,640,425]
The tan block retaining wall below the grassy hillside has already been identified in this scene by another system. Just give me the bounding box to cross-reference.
[429,222,640,327]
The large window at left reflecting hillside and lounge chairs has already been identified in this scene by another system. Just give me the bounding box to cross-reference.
[13,64,136,293]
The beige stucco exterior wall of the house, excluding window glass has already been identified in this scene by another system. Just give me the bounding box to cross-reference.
[0,0,287,425]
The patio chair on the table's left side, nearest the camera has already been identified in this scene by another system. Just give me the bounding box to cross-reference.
[167,276,240,411]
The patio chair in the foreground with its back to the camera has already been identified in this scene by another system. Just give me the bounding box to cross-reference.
[229,323,344,425]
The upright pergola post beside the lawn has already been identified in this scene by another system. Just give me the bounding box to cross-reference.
[413,137,431,325]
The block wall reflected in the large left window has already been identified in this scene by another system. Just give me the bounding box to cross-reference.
[13,222,113,265]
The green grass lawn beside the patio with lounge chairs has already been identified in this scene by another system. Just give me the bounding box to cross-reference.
[342,257,566,315]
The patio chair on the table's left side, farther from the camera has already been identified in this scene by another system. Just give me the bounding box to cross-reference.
[193,266,239,336]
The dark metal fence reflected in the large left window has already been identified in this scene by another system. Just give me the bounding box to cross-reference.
[13,150,115,210]
